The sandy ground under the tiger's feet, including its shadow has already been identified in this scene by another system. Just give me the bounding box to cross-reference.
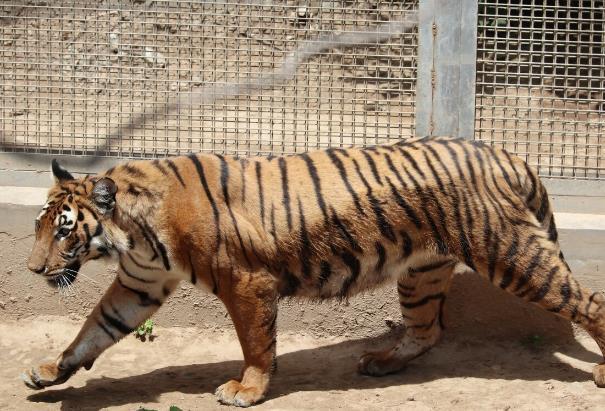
[0,317,605,410]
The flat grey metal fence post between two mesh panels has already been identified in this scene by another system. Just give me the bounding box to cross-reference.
[416,0,477,138]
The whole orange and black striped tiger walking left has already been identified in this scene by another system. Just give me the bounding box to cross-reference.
[23,138,605,406]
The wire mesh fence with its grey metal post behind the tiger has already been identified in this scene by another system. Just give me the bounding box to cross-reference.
[0,0,605,180]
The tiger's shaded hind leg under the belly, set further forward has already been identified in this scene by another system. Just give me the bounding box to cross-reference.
[358,260,456,376]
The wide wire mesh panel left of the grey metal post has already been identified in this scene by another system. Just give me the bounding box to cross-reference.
[0,0,417,157]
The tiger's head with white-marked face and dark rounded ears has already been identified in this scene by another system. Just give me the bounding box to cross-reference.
[27,160,123,286]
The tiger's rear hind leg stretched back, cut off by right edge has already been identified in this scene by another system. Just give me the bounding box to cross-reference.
[487,229,605,387]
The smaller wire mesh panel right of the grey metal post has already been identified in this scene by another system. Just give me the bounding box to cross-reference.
[475,0,605,179]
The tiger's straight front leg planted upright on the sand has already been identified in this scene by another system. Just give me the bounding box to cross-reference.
[215,271,278,407]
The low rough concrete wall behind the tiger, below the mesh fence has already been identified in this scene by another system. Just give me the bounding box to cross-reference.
[0,185,605,338]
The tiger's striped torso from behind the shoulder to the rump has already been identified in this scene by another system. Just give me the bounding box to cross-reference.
[159,138,537,298]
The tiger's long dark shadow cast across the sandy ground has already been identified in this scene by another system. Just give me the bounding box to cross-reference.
[28,331,601,410]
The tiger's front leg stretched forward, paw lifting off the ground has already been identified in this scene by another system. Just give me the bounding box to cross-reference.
[21,272,172,389]
